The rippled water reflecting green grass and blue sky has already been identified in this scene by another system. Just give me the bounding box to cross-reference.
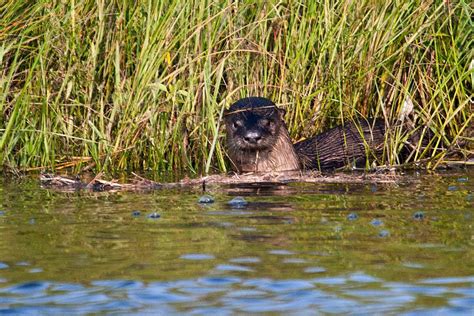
[0,169,474,315]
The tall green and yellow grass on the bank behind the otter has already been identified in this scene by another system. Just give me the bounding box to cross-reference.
[0,0,474,174]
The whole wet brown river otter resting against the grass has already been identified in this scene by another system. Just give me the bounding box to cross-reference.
[224,97,385,172]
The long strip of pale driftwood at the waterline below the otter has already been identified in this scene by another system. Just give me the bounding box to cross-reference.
[40,169,401,192]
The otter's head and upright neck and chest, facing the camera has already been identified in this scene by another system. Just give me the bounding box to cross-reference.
[224,97,299,172]
